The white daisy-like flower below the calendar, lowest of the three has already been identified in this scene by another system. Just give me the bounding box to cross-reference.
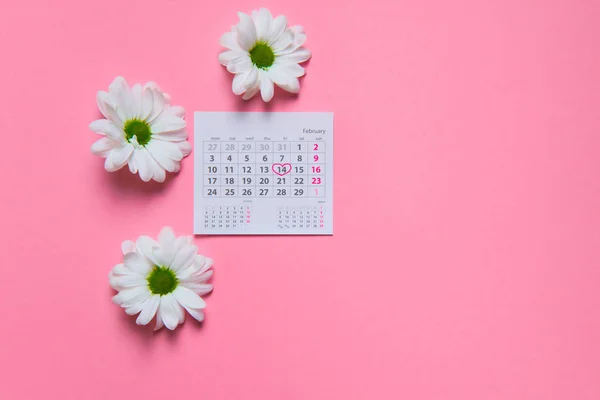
[108,227,213,330]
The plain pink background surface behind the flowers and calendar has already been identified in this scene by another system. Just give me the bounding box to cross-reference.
[0,0,600,400]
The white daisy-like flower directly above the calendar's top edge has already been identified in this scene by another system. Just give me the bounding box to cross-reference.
[219,8,311,102]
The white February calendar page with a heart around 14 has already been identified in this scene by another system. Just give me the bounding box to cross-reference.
[194,112,333,235]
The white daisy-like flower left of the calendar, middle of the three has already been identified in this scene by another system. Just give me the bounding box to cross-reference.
[90,76,192,182]
